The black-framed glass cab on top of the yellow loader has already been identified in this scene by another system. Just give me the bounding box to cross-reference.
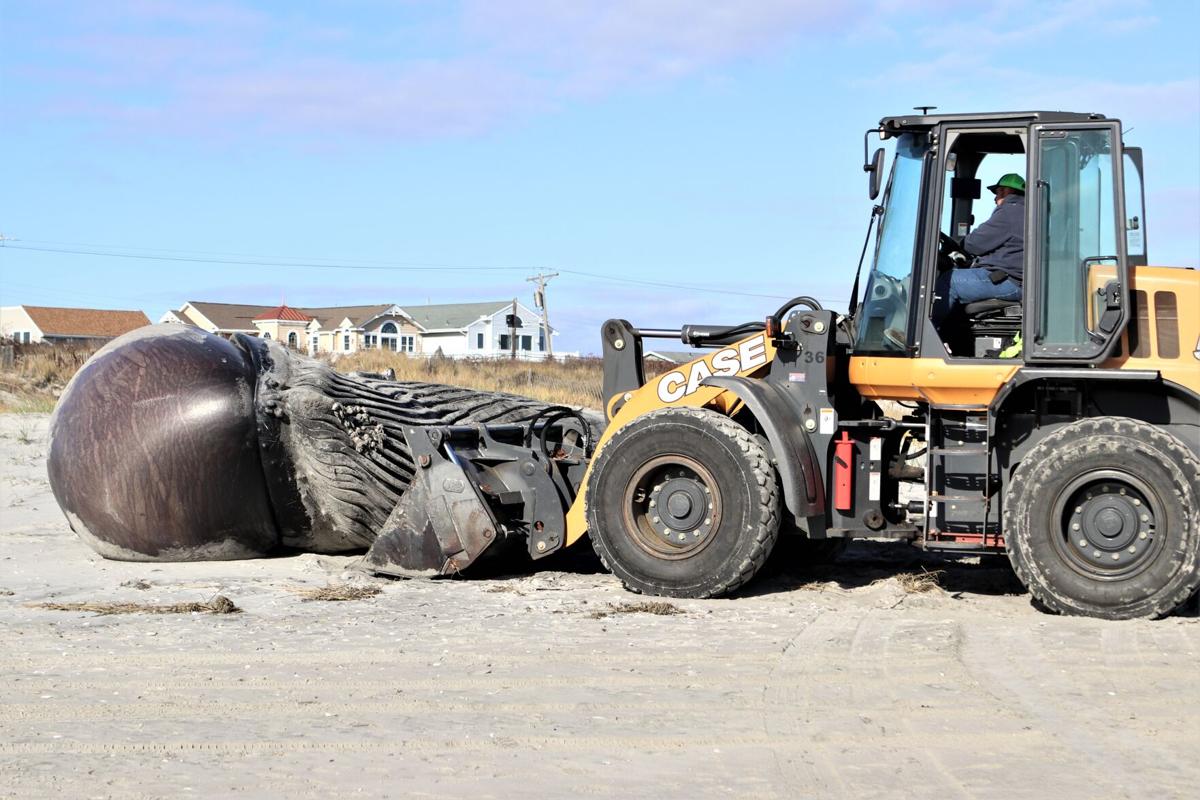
[854,112,1145,363]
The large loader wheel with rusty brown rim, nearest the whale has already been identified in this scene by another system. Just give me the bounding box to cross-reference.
[586,408,779,597]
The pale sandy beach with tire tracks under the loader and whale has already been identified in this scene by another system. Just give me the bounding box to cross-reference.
[0,415,1200,800]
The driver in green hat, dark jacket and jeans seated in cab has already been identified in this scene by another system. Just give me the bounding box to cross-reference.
[934,173,1025,319]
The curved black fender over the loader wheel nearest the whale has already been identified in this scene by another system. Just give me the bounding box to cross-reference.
[701,377,826,519]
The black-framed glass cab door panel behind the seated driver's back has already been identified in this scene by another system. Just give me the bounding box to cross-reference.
[1024,121,1129,363]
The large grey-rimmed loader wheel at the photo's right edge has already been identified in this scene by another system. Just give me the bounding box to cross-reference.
[1004,416,1200,619]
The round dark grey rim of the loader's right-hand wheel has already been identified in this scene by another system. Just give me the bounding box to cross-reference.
[1064,479,1156,571]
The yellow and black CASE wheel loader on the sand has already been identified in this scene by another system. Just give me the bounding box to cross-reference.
[357,112,1200,619]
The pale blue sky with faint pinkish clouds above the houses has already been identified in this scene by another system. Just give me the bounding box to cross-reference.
[0,0,1200,353]
